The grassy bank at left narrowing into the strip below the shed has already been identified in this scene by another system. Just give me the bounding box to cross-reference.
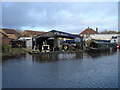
[2,48,84,59]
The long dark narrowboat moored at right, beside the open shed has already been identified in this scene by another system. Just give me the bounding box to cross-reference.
[88,41,117,51]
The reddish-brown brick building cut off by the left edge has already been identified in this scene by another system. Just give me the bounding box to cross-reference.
[0,32,11,45]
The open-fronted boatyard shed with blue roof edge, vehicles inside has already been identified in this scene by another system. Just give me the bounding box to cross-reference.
[33,30,83,51]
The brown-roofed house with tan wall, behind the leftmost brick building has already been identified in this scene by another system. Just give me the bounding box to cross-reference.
[0,28,20,39]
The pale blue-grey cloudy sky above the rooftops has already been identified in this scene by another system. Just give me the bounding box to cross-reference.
[2,2,118,33]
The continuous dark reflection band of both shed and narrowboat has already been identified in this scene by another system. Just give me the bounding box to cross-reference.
[32,51,116,63]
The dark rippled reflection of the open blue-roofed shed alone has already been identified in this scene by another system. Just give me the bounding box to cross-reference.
[32,52,83,63]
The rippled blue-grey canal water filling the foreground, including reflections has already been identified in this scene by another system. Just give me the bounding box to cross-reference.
[2,51,120,88]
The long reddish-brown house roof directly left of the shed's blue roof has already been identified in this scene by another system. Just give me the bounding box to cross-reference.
[22,30,45,37]
